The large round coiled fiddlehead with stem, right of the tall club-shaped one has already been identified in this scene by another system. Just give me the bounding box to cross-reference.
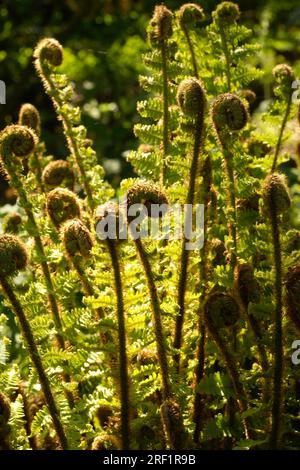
[212,93,248,265]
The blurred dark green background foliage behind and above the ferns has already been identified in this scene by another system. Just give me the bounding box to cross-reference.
[0,0,300,202]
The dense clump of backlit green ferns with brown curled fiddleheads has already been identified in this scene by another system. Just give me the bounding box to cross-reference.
[0,2,300,451]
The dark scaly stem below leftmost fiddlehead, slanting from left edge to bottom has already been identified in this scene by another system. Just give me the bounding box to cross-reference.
[0,276,68,450]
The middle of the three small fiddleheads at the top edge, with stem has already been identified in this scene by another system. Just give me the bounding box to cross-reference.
[178,3,204,78]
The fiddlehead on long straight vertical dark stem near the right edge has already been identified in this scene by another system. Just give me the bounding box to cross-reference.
[263,173,291,449]
